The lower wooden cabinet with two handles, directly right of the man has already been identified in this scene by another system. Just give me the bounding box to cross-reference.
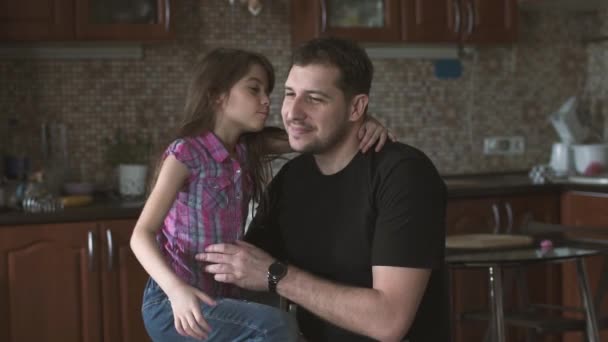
[447,193,561,342]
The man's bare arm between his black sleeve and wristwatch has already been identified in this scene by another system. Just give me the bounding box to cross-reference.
[277,266,430,341]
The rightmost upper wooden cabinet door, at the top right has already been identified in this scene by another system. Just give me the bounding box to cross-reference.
[460,0,517,44]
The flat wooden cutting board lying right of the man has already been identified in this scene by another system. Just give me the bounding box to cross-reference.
[445,234,534,249]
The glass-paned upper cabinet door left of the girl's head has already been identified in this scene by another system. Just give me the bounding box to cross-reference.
[76,0,173,41]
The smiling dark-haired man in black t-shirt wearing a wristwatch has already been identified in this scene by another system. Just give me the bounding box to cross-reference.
[199,38,449,342]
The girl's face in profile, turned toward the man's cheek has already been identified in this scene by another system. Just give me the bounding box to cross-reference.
[216,64,270,134]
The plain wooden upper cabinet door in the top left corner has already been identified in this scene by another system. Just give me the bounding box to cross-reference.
[0,0,74,41]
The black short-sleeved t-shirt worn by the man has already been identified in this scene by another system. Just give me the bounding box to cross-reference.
[246,143,449,342]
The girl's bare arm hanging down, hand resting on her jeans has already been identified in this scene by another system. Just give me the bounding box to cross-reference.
[130,155,215,339]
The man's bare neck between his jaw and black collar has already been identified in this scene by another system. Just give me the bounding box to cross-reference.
[313,128,359,175]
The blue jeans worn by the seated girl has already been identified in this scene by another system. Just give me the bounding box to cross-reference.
[142,279,297,342]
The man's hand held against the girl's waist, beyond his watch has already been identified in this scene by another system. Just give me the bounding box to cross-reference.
[196,241,274,291]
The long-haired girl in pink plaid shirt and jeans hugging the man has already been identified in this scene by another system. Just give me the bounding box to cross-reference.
[131,49,387,342]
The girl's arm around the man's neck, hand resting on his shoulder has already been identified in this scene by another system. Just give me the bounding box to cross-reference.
[260,115,397,154]
